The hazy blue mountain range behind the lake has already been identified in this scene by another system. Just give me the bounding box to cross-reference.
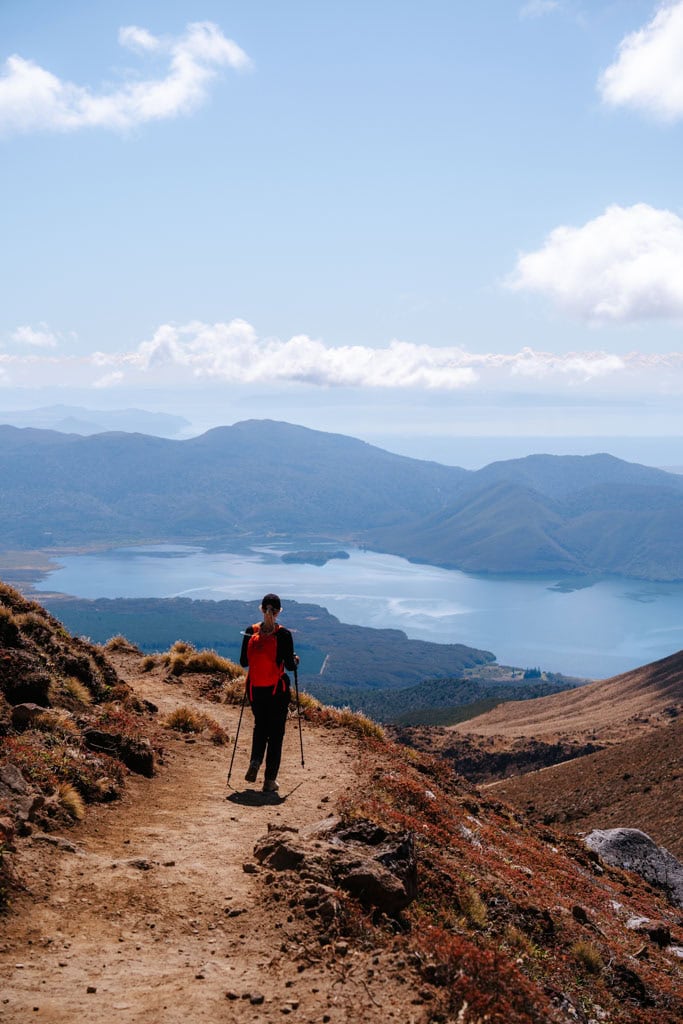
[0,420,683,581]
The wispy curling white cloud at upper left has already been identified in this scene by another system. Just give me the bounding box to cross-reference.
[0,22,250,133]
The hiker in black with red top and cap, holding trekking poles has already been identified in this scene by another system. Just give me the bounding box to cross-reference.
[240,594,299,793]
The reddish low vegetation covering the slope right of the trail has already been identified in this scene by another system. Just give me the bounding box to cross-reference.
[341,737,683,1024]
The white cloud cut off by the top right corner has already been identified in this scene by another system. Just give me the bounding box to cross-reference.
[598,0,683,121]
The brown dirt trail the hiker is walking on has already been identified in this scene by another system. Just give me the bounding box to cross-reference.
[0,659,426,1024]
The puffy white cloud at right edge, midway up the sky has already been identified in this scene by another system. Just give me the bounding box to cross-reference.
[507,203,683,323]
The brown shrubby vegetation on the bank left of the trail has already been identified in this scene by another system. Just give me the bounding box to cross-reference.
[0,583,154,905]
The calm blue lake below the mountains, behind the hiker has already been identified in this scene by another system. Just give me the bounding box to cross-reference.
[37,545,683,678]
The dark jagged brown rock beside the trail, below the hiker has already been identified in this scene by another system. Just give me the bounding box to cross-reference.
[254,819,418,916]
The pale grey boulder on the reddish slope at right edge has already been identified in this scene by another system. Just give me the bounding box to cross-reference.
[584,828,683,907]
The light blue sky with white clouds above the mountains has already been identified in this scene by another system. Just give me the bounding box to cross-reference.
[0,0,683,461]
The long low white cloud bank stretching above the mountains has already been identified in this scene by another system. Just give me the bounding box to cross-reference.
[5,319,683,395]
